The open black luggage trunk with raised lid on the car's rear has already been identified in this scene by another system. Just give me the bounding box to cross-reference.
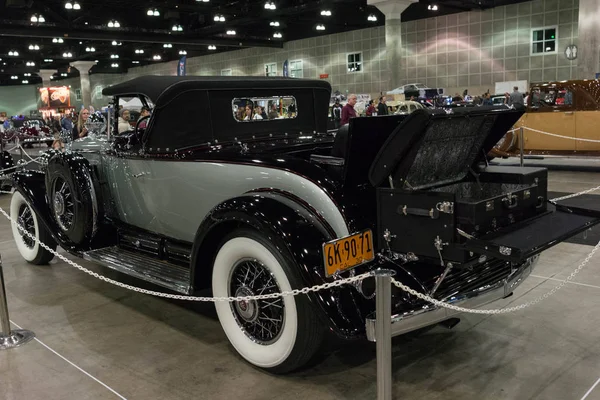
[369,107,600,265]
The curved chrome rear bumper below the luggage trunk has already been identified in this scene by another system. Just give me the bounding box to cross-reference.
[365,256,539,342]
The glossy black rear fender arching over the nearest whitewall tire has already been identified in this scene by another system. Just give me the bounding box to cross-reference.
[191,192,426,339]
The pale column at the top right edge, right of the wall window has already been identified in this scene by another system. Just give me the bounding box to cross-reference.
[576,0,600,79]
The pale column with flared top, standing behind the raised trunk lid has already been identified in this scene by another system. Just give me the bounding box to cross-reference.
[367,0,417,90]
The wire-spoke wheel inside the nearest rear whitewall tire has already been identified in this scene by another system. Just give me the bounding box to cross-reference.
[229,260,285,345]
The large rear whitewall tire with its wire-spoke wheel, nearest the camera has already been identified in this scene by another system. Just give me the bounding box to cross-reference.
[212,230,323,373]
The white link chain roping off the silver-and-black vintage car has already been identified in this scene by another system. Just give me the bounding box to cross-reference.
[0,181,600,315]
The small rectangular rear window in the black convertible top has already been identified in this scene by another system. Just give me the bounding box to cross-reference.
[231,96,298,122]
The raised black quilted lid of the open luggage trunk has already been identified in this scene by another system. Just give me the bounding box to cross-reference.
[369,107,523,190]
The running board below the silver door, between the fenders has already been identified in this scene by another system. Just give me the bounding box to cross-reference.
[83,246,191,294]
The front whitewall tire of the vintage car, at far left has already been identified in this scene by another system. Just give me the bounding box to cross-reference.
[10,191,56,265]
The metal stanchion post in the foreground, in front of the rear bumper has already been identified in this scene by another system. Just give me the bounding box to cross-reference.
[374,269,395,400]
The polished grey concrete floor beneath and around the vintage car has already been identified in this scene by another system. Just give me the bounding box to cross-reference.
[0,161,600,400]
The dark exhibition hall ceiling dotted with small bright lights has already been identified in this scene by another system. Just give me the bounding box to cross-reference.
[0,0,523,85]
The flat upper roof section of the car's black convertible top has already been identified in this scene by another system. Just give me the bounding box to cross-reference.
[102,75,331,107]
